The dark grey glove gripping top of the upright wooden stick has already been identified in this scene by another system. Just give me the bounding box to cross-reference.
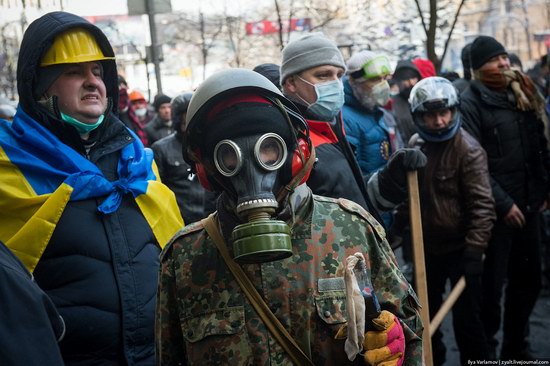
[378,148,428,204]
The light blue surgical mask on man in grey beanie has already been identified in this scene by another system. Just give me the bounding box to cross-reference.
[297,75,344,121]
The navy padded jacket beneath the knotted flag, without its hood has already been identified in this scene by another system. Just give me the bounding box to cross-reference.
[34,117,160,365]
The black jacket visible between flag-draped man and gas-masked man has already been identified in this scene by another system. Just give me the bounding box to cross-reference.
[151,134,220,225]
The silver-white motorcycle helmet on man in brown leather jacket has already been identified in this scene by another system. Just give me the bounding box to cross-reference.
[409,76,460,142]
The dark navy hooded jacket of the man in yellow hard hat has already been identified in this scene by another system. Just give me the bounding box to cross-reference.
[17,12,160,365]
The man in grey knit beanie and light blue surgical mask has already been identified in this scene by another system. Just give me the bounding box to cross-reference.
[281,33,426,221]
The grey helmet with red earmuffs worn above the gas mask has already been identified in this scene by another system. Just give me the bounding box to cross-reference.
[183,69,313,194]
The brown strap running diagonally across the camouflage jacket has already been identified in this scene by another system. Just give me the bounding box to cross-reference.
[202,214,313,366]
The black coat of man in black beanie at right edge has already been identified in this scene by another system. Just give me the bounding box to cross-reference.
[460,80,550,217]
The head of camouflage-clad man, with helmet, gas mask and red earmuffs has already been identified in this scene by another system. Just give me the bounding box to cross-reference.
[183,69,315,263]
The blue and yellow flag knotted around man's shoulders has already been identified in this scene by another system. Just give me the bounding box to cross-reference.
[0,108,183,272]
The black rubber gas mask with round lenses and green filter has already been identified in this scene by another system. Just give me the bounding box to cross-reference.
[213,133,292,263]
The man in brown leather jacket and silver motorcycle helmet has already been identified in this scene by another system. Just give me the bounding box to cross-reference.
[396,77,495,365]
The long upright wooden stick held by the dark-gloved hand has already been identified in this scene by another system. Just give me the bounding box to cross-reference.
[407,170,433,366]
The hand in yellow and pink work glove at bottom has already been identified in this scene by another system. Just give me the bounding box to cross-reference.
[363,310,405,366]
